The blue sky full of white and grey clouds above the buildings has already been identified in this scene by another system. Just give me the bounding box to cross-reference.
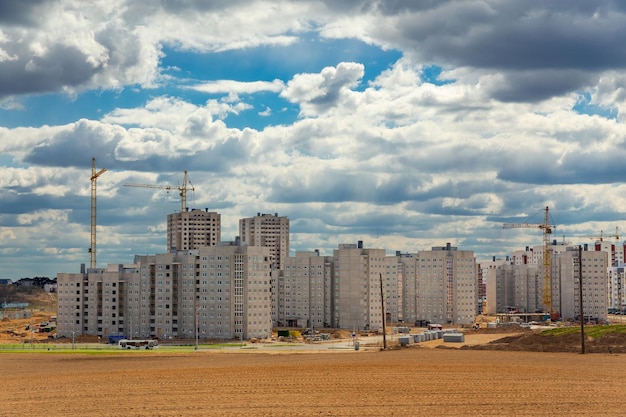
[0,0,626,279]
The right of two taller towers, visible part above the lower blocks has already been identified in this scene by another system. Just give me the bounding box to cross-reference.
[239,213,289,269]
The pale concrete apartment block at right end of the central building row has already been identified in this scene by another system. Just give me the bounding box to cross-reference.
[417,243,478,324]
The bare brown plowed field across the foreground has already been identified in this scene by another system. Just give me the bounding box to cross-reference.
[0,348,626,417]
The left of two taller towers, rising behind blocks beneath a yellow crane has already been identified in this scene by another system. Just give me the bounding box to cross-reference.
[167,209,222,252]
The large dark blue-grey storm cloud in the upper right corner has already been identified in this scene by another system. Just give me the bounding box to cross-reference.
[370,0,626,102]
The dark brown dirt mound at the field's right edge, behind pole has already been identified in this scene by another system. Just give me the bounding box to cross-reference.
[461,332,626,353]
